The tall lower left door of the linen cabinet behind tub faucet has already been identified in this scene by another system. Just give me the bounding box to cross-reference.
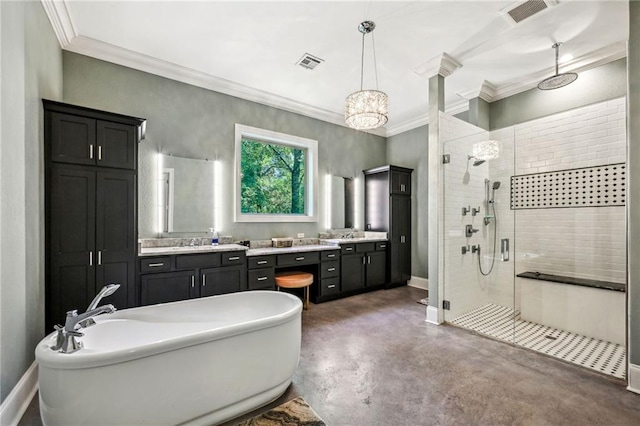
[46,167,97,331]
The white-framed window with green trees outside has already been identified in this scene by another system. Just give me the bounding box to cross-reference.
[235,124,318,222]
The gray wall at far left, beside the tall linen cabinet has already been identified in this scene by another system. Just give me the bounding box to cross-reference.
[0,1,62,401]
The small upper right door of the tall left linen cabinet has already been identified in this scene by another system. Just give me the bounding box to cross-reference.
[96,120,137,170]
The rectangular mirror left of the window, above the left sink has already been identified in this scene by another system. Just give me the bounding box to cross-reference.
[158,155,214,233]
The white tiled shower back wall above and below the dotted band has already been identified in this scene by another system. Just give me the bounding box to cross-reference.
[515,98,626,283]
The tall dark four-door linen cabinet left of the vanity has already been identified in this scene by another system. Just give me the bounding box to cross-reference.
[43,100,145,332]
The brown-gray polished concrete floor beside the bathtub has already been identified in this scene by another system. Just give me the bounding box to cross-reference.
[20,287,640,426]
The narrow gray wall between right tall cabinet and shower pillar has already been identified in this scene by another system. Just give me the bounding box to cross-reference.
[387,125,429,278]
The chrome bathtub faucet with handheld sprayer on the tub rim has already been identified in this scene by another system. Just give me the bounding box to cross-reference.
[51,284,120,354]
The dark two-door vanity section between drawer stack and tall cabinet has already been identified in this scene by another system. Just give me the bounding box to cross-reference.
[340,242,387,293]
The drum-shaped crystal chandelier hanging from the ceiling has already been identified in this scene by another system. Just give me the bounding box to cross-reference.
[344,21,389,130]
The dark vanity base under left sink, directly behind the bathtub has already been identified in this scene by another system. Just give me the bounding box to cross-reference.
[140,251,247,305]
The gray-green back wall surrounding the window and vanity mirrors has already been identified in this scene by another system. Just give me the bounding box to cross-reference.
[63,52,386,239]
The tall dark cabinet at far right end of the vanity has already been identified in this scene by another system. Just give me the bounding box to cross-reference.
[364,165,413,286]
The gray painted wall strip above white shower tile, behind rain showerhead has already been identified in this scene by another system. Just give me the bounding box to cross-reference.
[489,58,627,130]
